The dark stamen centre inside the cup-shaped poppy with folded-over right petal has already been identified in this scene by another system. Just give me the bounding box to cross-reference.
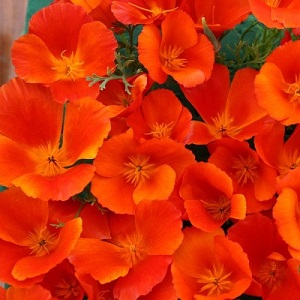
[200,195,231,221]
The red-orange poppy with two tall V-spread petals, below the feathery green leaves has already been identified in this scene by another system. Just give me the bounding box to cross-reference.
[182,64,267,144]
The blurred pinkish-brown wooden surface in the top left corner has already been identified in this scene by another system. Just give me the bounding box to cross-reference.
[0,0,27,85]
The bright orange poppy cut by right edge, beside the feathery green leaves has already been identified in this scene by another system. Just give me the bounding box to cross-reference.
[255,39,300,125]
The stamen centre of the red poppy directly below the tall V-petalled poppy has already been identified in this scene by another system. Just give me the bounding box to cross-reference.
[232,155,257,185]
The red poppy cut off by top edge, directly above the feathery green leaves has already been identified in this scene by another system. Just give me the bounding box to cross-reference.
[186,0,251,37]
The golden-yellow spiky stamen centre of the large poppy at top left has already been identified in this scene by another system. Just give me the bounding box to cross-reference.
[51,50,85,81]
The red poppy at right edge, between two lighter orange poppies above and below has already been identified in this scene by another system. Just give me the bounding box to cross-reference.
[254,121,300,186]
